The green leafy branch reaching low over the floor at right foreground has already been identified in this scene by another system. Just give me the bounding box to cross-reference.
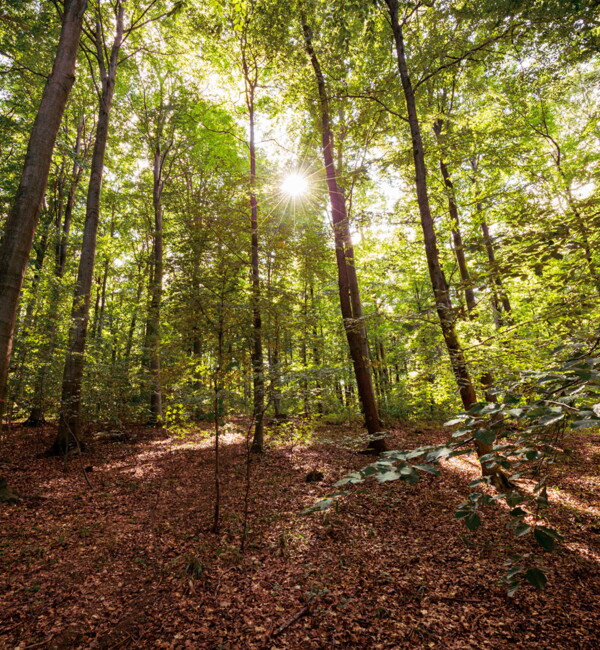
[303,356,600,596]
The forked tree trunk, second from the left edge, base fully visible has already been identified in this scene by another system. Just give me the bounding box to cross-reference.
[49,4,123,454]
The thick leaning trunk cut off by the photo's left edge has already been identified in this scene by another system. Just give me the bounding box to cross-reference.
[0,0,87,427]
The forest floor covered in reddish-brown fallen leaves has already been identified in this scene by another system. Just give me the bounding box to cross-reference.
[0,422,600,650]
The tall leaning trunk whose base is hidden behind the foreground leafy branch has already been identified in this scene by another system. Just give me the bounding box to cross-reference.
[385,0,507,488]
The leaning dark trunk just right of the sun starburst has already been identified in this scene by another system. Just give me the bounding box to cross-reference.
[302,17,386,452]
